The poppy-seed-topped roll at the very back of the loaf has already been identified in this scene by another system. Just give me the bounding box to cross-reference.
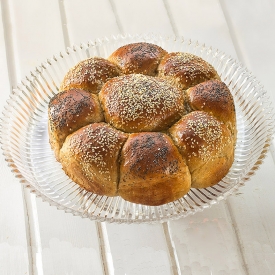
[108,42,167,76]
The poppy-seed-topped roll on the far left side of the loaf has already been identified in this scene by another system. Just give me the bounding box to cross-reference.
[48,89,104,160]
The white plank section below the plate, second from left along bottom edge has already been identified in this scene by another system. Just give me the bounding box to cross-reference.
[25,194,104,275]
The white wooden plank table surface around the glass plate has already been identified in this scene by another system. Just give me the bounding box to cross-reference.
[0,0,275,275]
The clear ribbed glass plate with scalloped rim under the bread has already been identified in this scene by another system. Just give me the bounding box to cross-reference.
[1,35,274,223]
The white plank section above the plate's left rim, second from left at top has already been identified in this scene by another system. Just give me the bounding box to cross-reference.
[9,0,64,81]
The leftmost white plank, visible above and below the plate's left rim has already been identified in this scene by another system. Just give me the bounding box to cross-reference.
[0,1,31,274]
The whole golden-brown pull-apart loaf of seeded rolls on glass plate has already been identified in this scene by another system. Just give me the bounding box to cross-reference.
[49,42,236,206]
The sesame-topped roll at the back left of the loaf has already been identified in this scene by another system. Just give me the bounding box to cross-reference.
[59,57,119,94]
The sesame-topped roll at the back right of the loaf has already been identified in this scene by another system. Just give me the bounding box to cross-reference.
[158,52,220,90]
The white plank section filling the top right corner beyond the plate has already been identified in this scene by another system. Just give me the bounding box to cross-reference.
[221,0,275,106]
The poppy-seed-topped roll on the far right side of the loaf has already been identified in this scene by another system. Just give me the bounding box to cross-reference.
[186,79,236,140]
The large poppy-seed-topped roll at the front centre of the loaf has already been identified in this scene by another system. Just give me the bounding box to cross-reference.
[119,132,191,205]
